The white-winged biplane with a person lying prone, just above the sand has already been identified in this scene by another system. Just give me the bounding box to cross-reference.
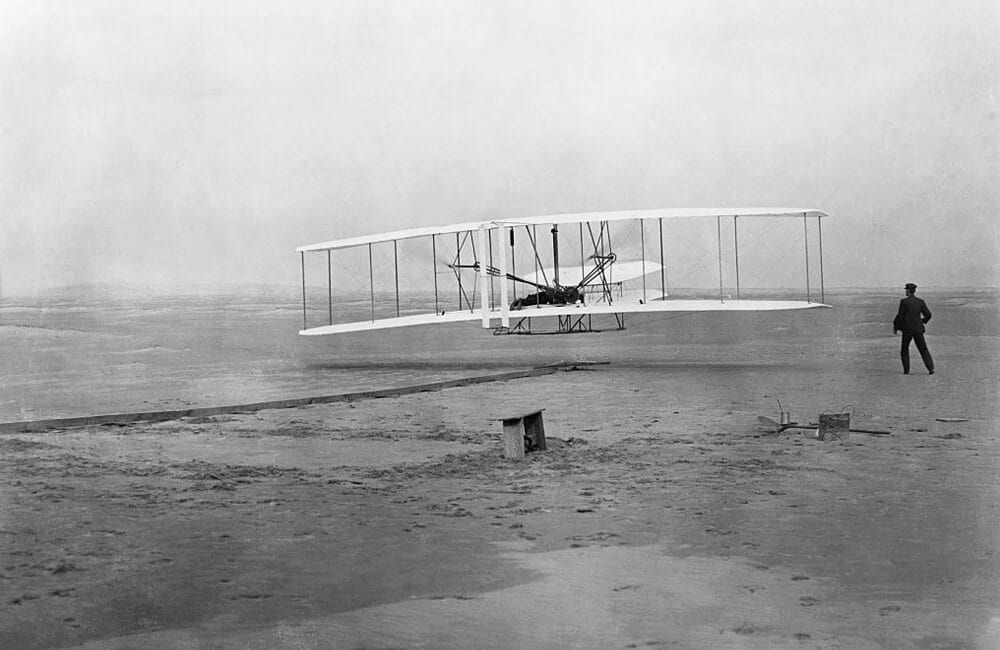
[296,208,829,336]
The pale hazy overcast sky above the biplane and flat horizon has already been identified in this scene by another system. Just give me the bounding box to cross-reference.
[0,0,1000,295]
